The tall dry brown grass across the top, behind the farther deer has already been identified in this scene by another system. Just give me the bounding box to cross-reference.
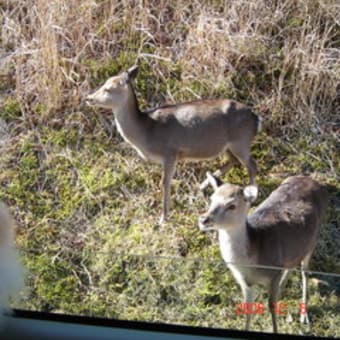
[1,0,340,129]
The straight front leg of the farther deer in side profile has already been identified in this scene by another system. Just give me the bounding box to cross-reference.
[159,157,176,224]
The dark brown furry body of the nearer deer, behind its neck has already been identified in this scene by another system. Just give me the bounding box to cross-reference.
[248,176,328,268]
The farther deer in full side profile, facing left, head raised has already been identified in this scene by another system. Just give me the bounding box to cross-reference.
[85,65,261,224]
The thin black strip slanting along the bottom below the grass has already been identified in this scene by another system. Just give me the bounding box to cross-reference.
[12,309,337,339]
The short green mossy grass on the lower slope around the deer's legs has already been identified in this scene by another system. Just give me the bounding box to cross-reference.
[0,107,340,336]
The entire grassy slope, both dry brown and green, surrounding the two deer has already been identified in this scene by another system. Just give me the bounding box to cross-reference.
[0,0,340,336]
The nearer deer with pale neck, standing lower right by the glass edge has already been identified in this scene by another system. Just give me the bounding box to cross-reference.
[198,173,328,333]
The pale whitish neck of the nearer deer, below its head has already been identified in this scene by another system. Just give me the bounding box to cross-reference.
[218,221,251,264]
